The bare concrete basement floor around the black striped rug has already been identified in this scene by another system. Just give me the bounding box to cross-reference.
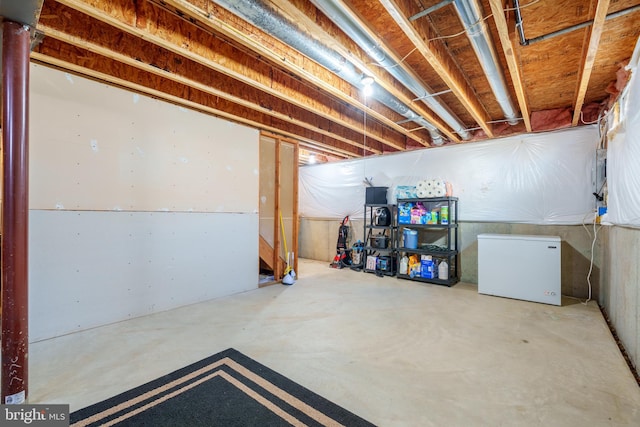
[29,260,640,426]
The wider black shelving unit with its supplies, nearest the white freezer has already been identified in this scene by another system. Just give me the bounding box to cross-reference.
[394,197,460,286]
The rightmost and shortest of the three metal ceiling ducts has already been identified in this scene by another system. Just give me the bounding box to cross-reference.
[453,0,518,125]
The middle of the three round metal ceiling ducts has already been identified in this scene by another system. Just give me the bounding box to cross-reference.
[311,0,471,140]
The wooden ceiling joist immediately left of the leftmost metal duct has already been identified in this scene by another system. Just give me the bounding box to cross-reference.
[142,0,431,150]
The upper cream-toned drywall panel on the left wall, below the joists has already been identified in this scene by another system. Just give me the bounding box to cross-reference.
[29,65,259,213]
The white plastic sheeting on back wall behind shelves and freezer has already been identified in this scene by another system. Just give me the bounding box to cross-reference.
[300,126,599,224]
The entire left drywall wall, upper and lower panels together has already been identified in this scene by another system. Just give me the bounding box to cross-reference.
[29,65,259,341]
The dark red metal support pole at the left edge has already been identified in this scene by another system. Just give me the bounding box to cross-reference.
[0,21,30,404]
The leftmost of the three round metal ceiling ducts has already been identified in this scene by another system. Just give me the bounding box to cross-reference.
[213,0,444,145]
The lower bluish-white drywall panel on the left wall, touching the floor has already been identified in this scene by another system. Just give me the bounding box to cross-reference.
[29,210,258,342]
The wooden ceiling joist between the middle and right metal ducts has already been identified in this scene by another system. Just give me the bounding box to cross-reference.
[380,0,494,138]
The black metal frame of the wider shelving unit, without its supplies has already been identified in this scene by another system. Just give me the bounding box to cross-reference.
[394,197,460,286]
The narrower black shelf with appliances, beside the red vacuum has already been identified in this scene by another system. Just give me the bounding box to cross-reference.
[363,203,398,276]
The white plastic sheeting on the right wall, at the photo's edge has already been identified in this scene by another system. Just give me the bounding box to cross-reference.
[603,39,640,227]
